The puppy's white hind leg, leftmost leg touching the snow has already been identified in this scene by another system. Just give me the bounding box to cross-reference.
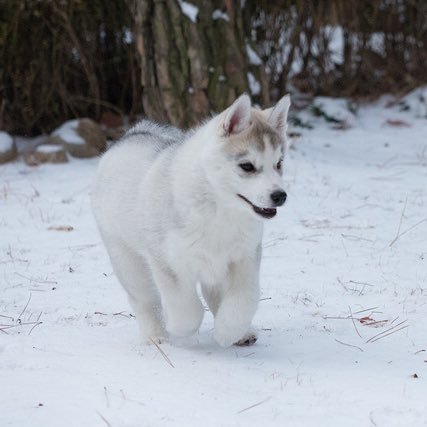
[104,236,167,344]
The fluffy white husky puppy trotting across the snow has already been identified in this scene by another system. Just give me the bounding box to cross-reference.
[92,95,290,347]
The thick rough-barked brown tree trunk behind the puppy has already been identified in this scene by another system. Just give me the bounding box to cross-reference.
[135,0,252,127]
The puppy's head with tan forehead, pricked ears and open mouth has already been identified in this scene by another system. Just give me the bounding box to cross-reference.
[204,95,291,218]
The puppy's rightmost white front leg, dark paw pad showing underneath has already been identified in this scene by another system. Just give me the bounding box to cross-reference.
[214,257,260,347]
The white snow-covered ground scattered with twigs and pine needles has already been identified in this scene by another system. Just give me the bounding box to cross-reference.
[0,98,427,427]
